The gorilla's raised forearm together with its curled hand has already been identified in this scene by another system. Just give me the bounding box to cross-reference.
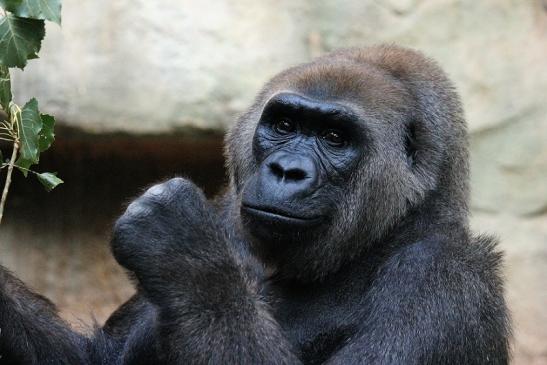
[112,179,299,364]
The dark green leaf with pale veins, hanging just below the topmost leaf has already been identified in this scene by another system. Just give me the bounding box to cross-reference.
[0,14,46,69]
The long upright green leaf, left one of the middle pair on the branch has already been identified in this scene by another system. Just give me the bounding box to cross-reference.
[15,98,42,176]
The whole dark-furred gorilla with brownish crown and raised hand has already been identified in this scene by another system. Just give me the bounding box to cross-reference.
[0,46,511,365]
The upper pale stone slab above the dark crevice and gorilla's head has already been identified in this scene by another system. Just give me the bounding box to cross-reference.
[10,0,547,136]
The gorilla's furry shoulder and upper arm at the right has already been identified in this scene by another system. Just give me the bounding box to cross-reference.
[327,237,509,365]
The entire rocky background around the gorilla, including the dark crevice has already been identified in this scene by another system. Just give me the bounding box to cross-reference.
[0,0,547,364]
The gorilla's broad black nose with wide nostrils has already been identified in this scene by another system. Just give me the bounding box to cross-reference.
[263,152,319,195]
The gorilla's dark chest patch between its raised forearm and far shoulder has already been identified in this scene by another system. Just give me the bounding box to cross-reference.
[274,284,356,364]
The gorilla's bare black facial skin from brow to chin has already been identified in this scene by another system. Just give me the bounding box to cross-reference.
[241,92,364,242]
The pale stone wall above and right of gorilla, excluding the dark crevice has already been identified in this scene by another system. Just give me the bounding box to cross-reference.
[4,0,547,364]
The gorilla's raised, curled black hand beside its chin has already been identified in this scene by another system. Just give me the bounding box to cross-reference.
[112,178,234,301]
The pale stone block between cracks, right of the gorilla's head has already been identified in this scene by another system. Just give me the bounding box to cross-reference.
[471,115,547,215]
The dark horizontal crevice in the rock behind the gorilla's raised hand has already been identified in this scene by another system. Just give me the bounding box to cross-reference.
[0,128,225,232]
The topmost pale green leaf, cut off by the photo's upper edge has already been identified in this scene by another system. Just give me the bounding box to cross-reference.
[0,0,61,25]
